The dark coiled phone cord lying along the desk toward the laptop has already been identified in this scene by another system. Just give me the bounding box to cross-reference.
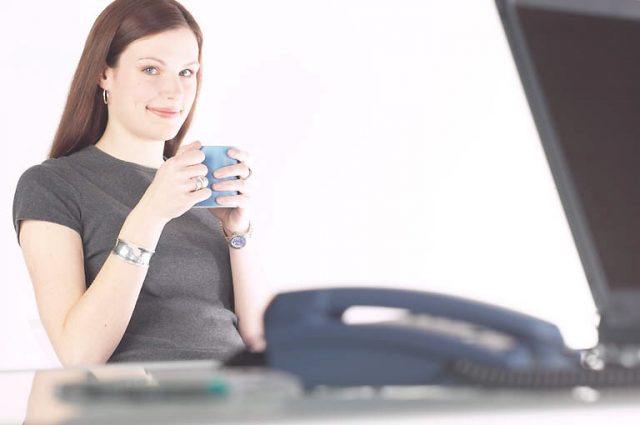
[450,360,640,389]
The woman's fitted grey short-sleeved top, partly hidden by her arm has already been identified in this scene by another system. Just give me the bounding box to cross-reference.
[13,145,244,362]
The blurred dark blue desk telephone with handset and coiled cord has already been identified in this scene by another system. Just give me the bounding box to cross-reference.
[265,288,640,387]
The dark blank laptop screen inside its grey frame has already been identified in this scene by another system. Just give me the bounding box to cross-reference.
[518,8,640,288]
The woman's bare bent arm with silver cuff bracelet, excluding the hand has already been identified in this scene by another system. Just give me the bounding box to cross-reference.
[20,205,164,366]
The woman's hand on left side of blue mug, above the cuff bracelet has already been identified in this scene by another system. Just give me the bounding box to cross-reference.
[136,142,211,224]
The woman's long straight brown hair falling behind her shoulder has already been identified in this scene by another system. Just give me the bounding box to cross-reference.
[49,0,202,158]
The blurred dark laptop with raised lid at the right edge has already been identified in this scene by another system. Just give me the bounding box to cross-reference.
[496,0,640,352]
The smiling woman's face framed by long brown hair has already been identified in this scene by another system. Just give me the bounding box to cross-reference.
[100,28,199,141]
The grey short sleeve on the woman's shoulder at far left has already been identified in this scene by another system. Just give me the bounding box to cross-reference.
[13,164,82,241]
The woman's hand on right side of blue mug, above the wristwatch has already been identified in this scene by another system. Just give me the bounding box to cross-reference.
[209,148,252,233]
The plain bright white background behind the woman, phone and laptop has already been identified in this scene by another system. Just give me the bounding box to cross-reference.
[0,0,596,369]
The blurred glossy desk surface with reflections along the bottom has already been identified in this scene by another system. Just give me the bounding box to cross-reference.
[0,361,640,424]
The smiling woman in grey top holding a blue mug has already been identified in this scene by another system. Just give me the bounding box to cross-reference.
[13,0,270,366]
